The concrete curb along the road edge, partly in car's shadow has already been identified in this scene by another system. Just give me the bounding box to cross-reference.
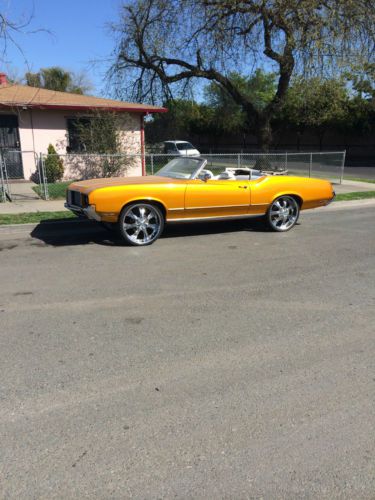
[0,198,375,235]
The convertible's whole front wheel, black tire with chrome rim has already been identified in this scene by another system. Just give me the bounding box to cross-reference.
[118,203,164,246]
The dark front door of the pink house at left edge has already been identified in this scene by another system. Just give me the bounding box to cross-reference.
[0,114,24,179]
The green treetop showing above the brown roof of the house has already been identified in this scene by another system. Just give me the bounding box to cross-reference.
[25,66,90,94]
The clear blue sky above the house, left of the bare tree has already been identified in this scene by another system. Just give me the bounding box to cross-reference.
[0,0,121,95]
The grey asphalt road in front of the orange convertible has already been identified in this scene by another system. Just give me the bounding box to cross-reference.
[0,207,375,499]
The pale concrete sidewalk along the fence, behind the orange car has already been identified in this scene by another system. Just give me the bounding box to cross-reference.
[0,181,375,214]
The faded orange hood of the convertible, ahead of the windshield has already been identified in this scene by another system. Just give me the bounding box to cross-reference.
[69,175,184,194]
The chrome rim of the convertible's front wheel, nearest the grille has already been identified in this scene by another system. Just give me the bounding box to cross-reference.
[123,204,161,245]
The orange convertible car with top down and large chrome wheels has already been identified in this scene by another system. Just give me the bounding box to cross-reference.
[65,157,335,245]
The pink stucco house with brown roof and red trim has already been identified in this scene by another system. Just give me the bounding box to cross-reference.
[0,73,167,179]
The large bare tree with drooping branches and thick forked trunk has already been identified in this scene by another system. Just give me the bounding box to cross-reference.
[110,0,375,150]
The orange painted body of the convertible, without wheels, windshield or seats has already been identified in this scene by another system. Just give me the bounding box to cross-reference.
[69,176,333,222]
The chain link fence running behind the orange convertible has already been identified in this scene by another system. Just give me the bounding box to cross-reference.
[0,151,345,202]
